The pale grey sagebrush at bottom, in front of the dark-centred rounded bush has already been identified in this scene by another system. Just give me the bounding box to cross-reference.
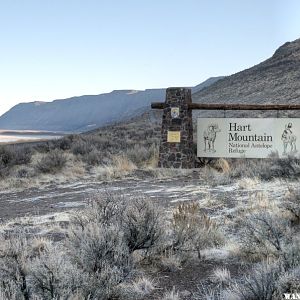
[68,223,133,299]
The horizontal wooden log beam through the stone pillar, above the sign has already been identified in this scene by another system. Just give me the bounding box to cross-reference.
[151,102,300,110]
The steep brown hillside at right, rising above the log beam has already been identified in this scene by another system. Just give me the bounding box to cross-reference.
[193,39,300,104]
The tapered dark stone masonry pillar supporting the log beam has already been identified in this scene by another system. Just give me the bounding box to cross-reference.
[158,88,195,169]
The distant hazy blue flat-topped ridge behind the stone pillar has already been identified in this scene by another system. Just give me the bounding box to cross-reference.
[0,77,222,132]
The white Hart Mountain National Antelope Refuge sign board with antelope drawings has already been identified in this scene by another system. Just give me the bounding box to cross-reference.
[197,118,300,158]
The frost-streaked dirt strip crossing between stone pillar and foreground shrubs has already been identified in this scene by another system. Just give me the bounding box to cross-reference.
[0,171,297,221]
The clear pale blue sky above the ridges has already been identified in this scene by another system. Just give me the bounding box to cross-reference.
[0,0,300,115]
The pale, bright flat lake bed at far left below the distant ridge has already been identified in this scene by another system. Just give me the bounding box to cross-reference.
[0,129,64,144]
